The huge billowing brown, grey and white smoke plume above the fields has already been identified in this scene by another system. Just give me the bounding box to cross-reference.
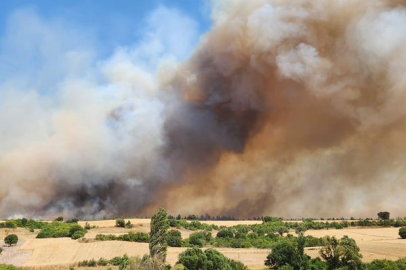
[0,0,406,218]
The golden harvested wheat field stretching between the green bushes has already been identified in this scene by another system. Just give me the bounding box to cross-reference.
[0,219,406,269]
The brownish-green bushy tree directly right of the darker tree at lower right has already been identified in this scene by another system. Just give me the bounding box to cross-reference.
[320,236,362,270]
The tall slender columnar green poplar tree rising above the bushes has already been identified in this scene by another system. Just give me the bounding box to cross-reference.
[149,208,169,261]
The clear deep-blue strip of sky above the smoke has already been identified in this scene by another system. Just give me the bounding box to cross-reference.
[0,0,210,53]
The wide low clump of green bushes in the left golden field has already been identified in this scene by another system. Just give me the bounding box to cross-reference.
[37,221,87,239]
